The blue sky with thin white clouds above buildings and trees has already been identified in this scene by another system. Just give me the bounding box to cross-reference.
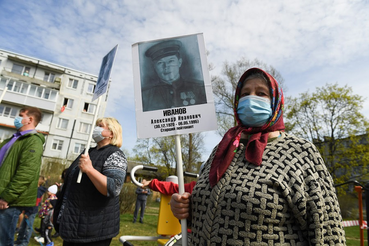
[0,0,369,160]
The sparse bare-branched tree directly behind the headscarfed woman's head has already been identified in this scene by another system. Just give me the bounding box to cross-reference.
[211,58,285,136]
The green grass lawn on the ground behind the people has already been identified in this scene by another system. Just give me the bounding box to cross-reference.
[20,206,368,246]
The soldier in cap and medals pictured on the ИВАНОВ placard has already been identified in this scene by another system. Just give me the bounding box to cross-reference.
[142,40,206,111]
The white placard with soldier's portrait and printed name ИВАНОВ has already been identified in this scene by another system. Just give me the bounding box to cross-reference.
[132,34,217,138]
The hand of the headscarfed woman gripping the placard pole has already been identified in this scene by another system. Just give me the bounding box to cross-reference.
[170,192,191,220]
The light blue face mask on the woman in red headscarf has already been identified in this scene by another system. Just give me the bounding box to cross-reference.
[237,95,272,127]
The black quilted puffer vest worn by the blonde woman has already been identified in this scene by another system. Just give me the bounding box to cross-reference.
[54,145,121,243]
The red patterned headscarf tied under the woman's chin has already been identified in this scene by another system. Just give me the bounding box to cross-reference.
[209,68,284,186]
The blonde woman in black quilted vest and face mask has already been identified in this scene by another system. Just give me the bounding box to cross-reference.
[54,118,127,246]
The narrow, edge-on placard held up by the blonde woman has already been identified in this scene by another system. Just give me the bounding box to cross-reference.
[92,45,118,101]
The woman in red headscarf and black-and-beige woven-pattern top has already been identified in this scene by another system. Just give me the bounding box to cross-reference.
[171,68,345,245]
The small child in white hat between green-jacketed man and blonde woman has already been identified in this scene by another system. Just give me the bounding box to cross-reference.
[35,185,58,243]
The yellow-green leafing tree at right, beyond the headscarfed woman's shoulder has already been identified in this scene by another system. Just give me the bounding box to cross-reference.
[286,84,369,192]
